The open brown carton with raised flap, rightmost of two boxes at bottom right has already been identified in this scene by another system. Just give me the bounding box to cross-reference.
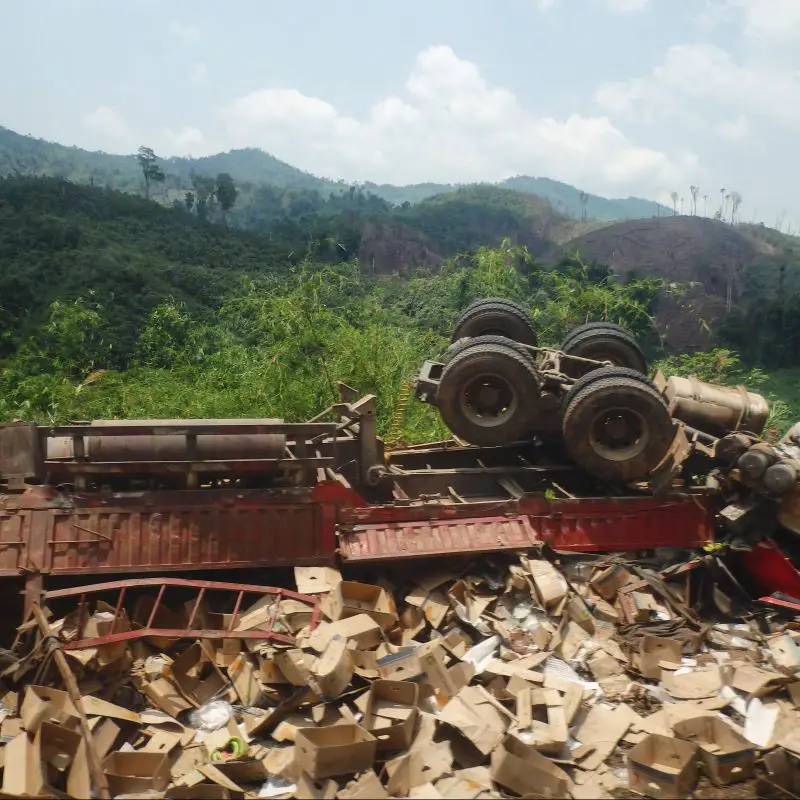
[672,716,756,786]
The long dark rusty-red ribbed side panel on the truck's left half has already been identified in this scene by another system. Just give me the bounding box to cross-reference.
[47,503,332,574]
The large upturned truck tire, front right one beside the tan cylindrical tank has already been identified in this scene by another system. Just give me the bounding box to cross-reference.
[562,373,675,483]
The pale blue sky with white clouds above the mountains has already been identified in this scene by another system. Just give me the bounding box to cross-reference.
[0,0,800,226]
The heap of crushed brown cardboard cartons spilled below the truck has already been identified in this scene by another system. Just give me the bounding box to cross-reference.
[0,553,800,798]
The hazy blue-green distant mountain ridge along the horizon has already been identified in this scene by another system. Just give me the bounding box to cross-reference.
[0,126,668,222]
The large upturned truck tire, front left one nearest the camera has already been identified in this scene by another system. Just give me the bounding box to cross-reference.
[437,344,540,446]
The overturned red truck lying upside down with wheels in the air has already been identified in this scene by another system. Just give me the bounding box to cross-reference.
[0,299,796,602]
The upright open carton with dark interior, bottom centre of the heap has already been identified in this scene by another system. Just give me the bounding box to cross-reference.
[364,680,419,752]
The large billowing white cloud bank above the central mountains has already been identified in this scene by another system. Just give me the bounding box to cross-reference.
[220,46,697,194]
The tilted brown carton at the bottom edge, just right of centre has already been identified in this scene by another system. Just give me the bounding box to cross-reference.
[491,735,572,797]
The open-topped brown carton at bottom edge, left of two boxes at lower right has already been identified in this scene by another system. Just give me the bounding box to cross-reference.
[628,733,697,798]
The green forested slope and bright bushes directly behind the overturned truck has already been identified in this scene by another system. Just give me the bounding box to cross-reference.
[0,177,794,442]
